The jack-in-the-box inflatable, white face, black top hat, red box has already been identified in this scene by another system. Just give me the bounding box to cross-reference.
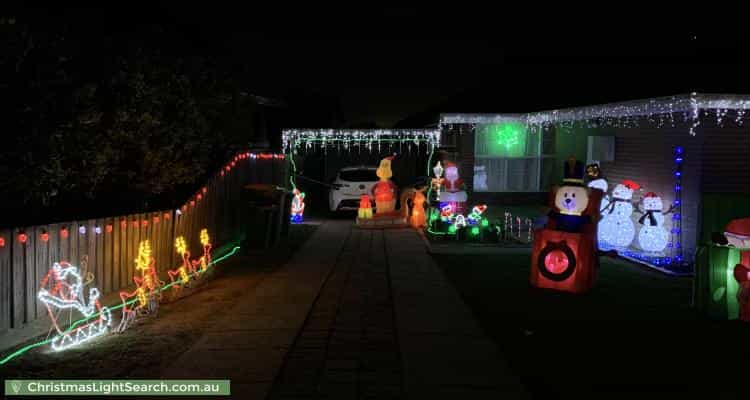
[530,159,603,293]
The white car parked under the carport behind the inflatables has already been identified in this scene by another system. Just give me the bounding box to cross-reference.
[328,166,379,211]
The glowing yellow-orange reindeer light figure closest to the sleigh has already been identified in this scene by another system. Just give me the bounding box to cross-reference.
[115,240,164,332]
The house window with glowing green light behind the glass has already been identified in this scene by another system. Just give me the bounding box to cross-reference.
[474,121,555,192]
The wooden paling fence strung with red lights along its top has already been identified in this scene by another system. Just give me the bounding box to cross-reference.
[0,152,288,333]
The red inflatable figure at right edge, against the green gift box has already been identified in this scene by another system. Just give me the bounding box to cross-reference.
[712,218,750,322]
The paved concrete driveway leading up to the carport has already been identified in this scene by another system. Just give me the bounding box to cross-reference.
[167,221,522,399]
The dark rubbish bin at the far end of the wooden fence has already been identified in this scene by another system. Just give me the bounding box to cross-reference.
[242,184,291,249]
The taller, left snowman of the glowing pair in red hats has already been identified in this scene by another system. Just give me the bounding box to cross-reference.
[598,180,640,248]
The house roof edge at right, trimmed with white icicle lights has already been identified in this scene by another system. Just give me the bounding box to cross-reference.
[440,93,750,124]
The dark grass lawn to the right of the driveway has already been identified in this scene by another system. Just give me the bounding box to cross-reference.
[435,255,750,399]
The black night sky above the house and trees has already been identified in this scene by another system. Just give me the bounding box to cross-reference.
[17,4,750,126]
